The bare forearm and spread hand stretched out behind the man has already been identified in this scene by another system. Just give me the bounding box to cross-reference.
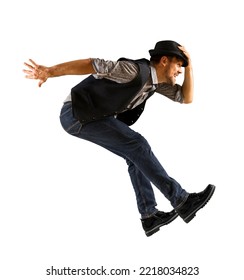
[23,58,95,87]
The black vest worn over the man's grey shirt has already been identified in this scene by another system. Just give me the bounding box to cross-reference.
[71,58,153,125]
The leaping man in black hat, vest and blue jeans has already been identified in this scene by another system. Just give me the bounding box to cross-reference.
[24,40,215,236]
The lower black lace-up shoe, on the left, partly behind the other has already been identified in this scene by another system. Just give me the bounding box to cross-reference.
[141,210,178,236]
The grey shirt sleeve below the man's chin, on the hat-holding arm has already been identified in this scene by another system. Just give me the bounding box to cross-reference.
[156,83,184,103]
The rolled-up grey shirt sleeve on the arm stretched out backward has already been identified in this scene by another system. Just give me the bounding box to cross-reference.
[92,58,139,83]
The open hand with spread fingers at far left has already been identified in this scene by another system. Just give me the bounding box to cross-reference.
[23,59,49,87]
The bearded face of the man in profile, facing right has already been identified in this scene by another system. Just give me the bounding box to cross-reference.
[165,57,183,85]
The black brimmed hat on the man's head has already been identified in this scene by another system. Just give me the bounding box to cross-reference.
[149,40,188,67]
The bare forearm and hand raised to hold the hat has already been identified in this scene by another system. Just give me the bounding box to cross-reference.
[179,47,194,103]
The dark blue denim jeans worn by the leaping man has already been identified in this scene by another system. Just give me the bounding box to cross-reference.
[60,102,188,218]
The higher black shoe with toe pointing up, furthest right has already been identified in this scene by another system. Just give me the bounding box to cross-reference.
[176,185,215,223]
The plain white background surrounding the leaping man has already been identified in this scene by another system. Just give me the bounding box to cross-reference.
[0,0,244,280]
